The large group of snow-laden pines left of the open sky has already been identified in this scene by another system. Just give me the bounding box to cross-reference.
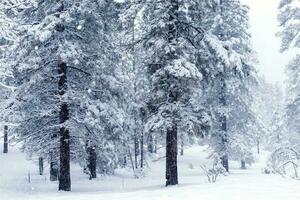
[0,0,262,191]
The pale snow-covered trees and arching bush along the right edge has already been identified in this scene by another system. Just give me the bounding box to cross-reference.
[269,0,300,178]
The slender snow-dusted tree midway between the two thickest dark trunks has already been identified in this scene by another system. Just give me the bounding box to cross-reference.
[120,1,149,173]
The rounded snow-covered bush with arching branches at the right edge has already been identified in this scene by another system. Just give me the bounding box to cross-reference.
[264,147,300,179]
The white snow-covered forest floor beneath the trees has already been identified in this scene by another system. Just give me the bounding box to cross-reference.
[0,147,300,200]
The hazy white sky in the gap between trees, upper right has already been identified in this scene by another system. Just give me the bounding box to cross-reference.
[241,0,293,84]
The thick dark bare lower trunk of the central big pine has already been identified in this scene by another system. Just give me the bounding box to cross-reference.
[166,125,178,186]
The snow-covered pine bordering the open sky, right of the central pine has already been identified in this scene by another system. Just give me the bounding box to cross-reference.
[207,0,256,171]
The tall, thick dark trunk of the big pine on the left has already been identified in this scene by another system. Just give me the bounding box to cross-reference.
[58,62,71,191]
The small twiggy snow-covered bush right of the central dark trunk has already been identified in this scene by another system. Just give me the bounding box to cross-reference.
[201,155,226,183]
